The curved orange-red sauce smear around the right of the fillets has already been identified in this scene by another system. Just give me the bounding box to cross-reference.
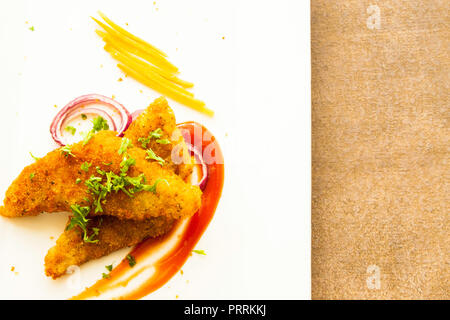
[72,122,224,299]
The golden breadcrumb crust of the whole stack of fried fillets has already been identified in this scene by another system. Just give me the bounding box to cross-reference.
[0,98,201,279]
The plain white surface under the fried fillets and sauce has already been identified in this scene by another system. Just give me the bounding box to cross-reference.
[0,0,310,299]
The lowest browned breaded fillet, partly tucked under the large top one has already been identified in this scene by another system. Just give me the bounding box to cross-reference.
[45,216,174,279]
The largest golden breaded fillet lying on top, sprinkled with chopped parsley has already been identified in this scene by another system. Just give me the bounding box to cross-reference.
[0,131,201,220]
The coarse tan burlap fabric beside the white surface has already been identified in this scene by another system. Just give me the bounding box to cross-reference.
[311,0,450,299]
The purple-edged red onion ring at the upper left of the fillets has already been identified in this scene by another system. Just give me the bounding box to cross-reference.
[50,94,132,146]
